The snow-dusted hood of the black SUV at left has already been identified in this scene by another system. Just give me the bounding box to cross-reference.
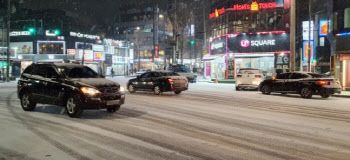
[70,78,119,88]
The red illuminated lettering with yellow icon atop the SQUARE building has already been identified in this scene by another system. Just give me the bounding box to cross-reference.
[229,1,277,11]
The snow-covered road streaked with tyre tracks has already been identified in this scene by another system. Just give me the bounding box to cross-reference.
[0,78,350,160]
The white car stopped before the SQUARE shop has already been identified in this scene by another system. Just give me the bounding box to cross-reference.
[236,68,264,91]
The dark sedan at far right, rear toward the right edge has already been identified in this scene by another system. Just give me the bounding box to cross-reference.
[259,72,341,98]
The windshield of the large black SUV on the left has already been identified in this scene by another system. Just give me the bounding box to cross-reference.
[58,66,101,78]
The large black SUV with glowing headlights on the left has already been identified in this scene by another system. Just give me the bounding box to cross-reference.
[17,63,125,118]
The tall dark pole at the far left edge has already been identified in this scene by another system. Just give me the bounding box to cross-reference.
[6,0,11,82]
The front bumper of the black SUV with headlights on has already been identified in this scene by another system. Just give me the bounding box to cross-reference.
[82,93,125,110]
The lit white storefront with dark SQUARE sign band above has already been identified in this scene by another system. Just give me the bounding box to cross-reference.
[206,31,289,79]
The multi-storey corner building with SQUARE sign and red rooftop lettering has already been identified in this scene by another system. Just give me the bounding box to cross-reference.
[203,0,290,79]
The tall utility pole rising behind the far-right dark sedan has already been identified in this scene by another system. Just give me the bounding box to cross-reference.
[290,0,296,71]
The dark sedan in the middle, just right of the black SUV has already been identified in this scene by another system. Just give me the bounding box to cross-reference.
[126,71,188,95]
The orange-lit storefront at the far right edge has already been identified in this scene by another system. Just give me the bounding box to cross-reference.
[333,33,350,91]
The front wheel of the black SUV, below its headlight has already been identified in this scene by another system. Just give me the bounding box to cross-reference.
[66,97,84,118]
